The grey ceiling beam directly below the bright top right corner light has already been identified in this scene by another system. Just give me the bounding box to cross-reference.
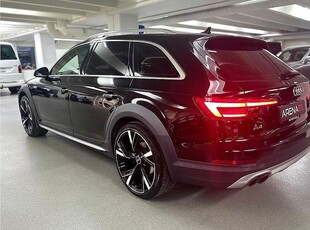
[244,10,310,30]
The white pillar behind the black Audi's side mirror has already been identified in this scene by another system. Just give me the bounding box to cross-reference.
[34,33,56,69]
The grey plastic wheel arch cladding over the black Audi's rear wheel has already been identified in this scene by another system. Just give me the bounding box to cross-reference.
[107,104,177,180]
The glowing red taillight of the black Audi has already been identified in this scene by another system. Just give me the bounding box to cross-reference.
[195,97,278,118]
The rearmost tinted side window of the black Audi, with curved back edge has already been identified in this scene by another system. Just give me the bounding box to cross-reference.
[134,42,179,78]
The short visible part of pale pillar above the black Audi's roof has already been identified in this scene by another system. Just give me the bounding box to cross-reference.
[108,14,138,31]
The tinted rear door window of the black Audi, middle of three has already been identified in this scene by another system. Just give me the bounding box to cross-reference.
[86,42,129,76]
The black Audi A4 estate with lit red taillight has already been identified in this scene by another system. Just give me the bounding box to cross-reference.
[19,34,310,199]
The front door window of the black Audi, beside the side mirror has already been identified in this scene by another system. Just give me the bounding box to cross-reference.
[51,44,90,75]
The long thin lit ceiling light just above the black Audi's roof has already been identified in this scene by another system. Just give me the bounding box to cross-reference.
[178,20,269,34]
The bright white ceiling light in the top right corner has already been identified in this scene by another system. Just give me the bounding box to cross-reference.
[270,4,310,21]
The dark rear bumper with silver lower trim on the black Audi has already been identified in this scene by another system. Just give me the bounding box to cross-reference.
[171,123,310,188]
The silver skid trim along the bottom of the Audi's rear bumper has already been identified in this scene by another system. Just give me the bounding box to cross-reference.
[227,147,310,188]
